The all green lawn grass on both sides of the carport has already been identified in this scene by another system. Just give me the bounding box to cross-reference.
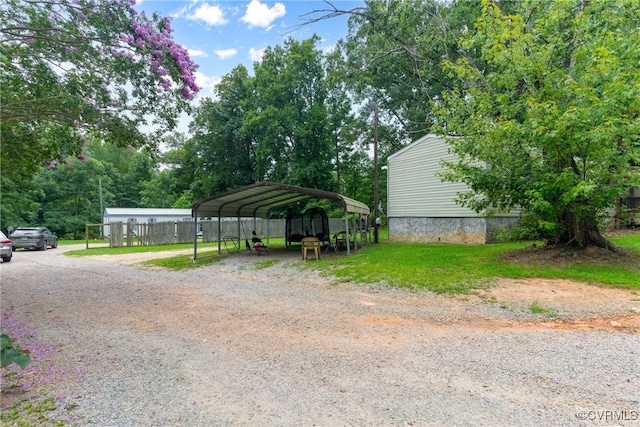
[63,231,640,293]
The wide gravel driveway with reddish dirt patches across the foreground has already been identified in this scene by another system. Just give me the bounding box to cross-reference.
[0,247,640,426]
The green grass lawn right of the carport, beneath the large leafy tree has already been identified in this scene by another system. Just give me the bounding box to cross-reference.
[325,235,640,293]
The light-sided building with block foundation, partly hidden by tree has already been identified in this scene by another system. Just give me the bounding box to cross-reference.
[387,134,519,243]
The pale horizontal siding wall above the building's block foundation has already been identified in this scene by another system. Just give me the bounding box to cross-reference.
[387,135,477,218]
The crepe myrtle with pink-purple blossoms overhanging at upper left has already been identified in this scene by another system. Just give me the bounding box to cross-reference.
[0,0,198,177]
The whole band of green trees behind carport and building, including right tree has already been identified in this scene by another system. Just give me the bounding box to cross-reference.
[1,0,640,245]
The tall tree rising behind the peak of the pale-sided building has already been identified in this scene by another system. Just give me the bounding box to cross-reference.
[342,0,479,144]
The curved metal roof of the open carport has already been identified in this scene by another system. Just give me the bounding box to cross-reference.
[192,181,369,218]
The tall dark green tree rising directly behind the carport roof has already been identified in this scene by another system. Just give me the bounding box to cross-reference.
[243,36,335,190]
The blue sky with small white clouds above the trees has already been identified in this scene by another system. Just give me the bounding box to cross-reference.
[136,0,364,97]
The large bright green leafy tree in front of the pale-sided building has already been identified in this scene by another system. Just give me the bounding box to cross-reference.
[436,0,640,247]
